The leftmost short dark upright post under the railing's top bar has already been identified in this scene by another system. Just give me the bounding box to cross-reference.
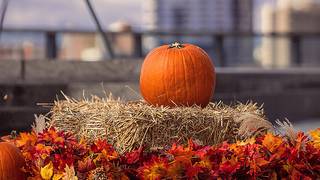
[46,32,58,60]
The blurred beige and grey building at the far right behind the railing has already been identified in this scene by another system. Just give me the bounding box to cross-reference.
[257,0,320,67]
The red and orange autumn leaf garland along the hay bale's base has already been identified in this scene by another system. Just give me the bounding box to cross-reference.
[9,128,320,180]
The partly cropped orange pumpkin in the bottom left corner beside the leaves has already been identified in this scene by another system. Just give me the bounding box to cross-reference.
[0,142,25,180]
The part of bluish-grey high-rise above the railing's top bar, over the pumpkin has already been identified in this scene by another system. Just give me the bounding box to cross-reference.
[143,0,252,32]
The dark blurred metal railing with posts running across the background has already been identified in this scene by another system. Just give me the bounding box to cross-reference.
[3,29,320,67]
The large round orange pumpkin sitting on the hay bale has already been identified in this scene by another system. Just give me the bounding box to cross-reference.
[140,42,216,107]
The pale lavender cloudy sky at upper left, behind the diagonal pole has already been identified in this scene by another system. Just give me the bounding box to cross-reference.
[0,0,143,30]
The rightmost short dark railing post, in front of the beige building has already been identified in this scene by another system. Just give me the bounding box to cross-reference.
[290,34,302,66]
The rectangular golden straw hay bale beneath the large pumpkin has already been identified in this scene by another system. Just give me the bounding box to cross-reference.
[49,97,272,153]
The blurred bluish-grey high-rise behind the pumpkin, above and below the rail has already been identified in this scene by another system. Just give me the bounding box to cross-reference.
[143,0,253,65]
